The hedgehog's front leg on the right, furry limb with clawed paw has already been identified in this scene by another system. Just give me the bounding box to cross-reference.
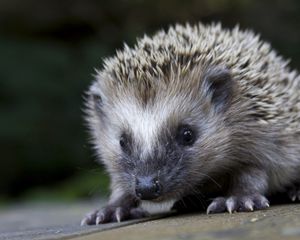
[207,168,269,213]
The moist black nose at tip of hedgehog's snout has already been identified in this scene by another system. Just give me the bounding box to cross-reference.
[135,177,161,200]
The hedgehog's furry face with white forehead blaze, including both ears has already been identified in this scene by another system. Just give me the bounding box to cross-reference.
[88,65,236,201]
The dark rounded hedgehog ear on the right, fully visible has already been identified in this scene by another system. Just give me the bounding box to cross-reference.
[203,67,234,112]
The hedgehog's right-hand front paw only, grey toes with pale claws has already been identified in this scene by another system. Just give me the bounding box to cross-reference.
[207,194,270,214]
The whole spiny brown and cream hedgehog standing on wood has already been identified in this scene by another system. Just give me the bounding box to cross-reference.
[82,23,300,225]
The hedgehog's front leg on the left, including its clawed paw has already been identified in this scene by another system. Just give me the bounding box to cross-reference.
[81,190,148,225]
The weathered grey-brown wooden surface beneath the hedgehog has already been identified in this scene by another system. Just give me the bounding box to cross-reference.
[0,201,300,240]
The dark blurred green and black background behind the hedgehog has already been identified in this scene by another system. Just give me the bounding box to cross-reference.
[0,0,300,203]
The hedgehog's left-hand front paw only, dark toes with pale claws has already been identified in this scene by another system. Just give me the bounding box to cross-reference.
[81,205,149,226]
